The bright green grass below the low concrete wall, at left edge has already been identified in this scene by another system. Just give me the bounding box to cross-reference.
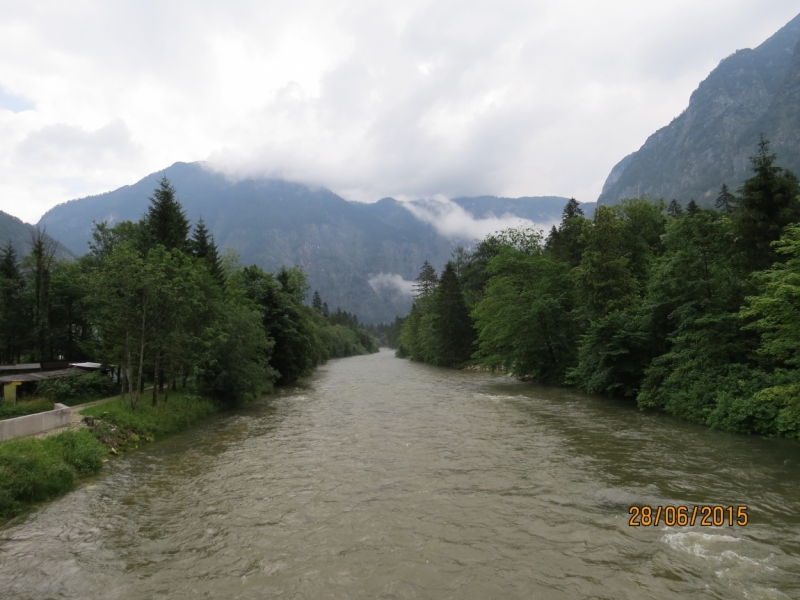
[0,429,108,519]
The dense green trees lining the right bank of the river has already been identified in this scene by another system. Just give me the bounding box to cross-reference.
[400,139,800,438]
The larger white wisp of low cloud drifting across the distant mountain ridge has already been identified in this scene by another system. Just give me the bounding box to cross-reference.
[402,198,542,240]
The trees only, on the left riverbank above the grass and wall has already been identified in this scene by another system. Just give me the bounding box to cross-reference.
[0,177,377,408]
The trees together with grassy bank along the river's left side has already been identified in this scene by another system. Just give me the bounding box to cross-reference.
[0,178,378,519]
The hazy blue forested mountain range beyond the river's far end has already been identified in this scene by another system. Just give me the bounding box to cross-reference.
[39,163,567,322]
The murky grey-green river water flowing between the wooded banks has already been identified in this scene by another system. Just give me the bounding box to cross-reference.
[0,350,800,600]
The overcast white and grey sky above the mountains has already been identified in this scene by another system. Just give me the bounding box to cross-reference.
[0,0,798,223]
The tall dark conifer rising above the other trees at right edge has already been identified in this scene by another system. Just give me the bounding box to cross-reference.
[733,136,800,271]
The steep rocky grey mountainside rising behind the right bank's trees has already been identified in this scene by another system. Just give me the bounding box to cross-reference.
[598,15,800,206]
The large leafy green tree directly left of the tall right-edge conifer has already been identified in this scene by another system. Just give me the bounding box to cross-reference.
[637,210,754,423]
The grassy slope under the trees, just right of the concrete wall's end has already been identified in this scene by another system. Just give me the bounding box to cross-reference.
[81,390,221,451]
